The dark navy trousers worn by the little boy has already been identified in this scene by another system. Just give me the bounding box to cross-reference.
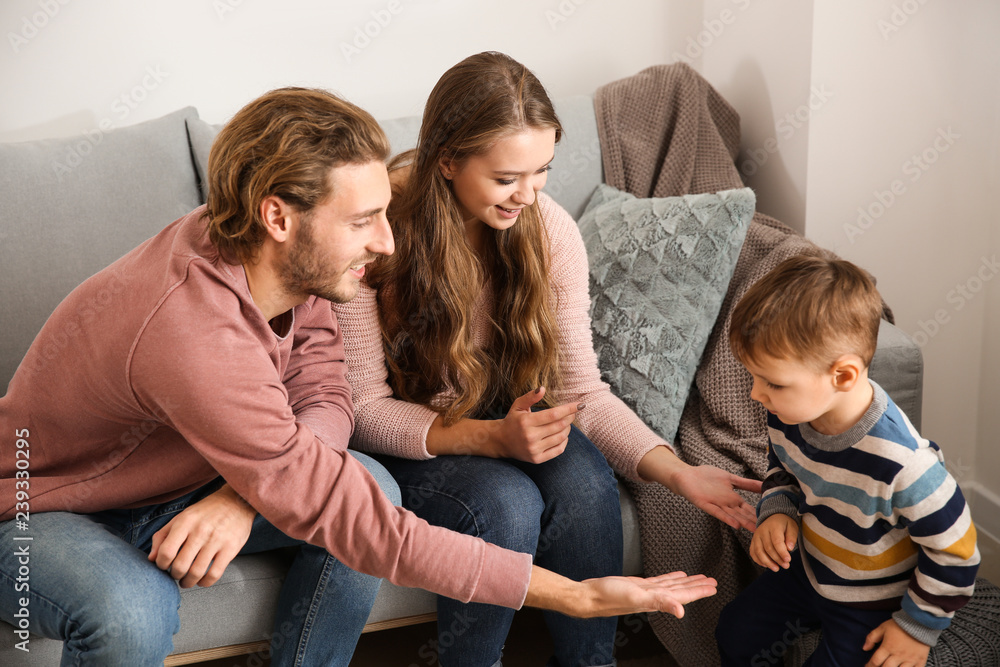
[715,550,898,667]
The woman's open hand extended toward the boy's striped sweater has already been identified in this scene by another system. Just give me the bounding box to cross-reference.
[637,446,761,531]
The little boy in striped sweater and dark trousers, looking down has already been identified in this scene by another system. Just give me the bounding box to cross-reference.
[716,256,979,667]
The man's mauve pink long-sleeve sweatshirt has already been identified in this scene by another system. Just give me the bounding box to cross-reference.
[0,207,531,608]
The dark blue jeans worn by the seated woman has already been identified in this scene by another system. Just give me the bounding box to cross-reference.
[379,426,622,667]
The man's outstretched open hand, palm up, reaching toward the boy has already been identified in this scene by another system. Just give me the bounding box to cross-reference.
[524,565,716,618]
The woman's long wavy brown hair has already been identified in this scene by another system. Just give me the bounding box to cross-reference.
[368,52,562,424]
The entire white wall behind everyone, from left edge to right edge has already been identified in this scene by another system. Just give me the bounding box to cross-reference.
[0,0,1000,494]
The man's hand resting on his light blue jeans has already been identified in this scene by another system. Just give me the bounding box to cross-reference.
[149,484,257,588]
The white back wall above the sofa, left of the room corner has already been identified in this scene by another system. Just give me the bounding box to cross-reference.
[0,0,684,141]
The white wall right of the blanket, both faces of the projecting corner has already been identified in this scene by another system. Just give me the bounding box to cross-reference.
[701,0,1000,509]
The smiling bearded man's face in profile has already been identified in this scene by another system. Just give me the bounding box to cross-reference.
[278,160,394,303]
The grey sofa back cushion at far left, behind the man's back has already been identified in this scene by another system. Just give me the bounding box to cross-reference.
[0,107,201,392]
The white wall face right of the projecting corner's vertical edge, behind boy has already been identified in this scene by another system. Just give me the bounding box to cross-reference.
[806,0,1000,490]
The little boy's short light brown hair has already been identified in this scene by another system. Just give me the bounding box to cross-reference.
[729,255,882,371]
